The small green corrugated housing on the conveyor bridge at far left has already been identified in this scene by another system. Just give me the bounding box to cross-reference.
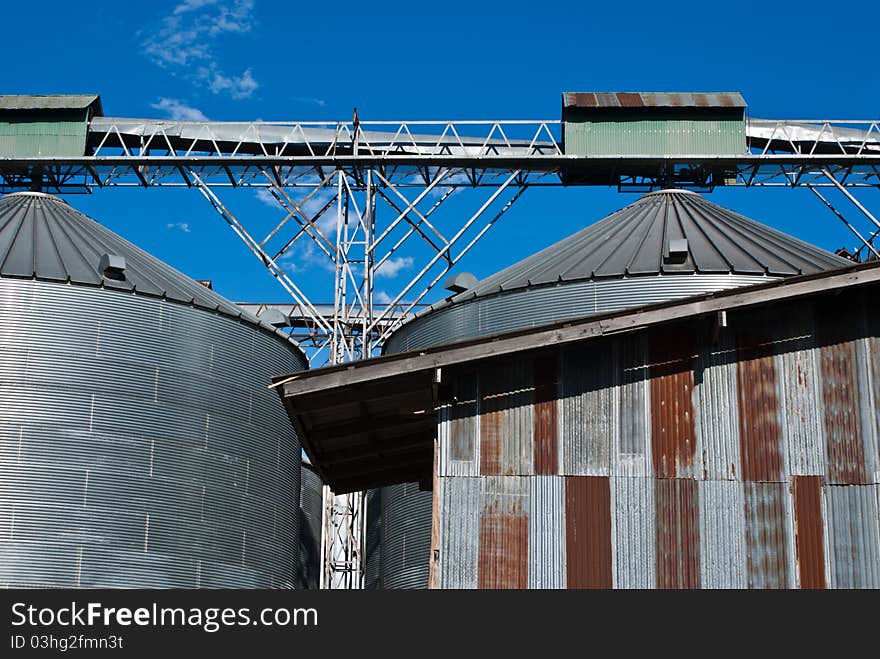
[0,94,103,158]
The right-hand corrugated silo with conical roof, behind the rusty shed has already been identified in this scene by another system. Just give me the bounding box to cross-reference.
[368,190,851,587]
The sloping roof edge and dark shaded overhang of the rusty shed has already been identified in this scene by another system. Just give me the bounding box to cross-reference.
[272,262,880,493]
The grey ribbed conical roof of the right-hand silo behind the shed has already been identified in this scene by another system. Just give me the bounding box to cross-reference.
[453,190,851,301]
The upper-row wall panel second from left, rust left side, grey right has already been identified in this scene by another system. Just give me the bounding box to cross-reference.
[479,359,534,475]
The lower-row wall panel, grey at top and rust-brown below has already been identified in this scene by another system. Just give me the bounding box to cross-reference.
[477,476,530,589]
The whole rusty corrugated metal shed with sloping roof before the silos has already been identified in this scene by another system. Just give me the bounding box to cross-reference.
[278,195,880,588]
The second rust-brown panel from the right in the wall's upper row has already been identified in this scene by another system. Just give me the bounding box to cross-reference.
[736,336,783,482]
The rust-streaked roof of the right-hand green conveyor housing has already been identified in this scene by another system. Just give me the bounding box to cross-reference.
[562,92,747,108]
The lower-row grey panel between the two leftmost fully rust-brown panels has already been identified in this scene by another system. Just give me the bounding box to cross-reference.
[611,478,657,589]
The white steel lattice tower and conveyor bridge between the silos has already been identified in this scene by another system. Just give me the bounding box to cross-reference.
[0,113,880,588]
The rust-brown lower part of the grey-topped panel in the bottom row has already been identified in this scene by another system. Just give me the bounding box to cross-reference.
[478,512,529,588]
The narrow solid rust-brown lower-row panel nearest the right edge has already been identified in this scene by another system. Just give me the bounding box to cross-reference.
[792,476,825,588]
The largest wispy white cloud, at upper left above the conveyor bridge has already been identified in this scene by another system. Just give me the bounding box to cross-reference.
[143,0,259,99]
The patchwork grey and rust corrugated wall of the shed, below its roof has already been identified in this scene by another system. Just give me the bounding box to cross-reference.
[435,288,880,588]
